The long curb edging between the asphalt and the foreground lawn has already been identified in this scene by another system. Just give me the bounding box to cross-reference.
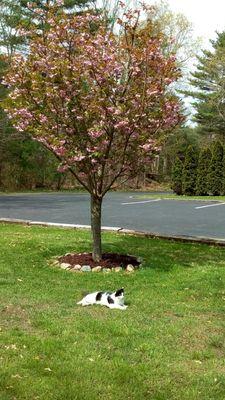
[0,218,225,247]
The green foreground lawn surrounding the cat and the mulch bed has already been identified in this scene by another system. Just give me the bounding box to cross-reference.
[0,224,225,400]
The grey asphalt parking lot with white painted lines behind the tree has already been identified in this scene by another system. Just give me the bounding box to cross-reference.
[0,192,225,239]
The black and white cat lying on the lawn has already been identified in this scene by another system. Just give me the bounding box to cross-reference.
[77,288,127,310]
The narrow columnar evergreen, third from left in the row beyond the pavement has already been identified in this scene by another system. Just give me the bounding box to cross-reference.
[196,148,212,196]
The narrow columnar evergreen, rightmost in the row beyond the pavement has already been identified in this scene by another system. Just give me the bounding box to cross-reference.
[208,140,224,196]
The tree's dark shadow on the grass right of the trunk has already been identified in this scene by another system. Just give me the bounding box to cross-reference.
[100,234,225,271]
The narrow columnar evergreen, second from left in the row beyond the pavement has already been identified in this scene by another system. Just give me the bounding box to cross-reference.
[182,145,198,196]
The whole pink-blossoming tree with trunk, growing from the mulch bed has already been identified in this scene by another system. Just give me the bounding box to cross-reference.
[5,0,181,261]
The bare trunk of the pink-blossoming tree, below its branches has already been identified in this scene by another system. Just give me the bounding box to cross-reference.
[91,195,102,261]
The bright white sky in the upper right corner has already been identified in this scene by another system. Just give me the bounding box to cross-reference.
[163,0,225,47]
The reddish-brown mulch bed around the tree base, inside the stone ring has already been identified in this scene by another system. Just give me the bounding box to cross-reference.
[59,253,140,268]
